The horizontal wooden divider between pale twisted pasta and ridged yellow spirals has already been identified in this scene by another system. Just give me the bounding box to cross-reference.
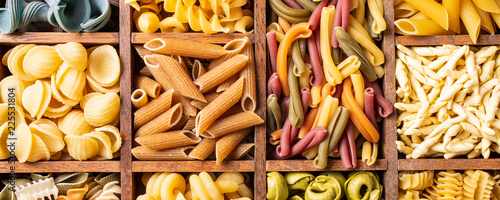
[398,158,500,170]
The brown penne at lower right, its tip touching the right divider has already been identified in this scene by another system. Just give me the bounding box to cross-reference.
[201,111,264,138]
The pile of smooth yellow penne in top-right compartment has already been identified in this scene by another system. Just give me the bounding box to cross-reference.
[394,0,500,43]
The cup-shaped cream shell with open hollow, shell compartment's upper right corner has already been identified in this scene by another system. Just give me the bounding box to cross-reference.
[88,45,121,87]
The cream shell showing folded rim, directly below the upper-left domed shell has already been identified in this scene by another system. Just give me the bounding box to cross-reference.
[22,80,52,119]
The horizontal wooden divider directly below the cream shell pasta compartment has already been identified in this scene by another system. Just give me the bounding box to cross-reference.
[0,160,120,173]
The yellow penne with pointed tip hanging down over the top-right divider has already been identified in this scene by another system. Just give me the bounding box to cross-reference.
[460,0,481,44]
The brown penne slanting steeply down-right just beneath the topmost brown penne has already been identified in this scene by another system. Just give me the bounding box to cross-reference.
[153,55,206,102]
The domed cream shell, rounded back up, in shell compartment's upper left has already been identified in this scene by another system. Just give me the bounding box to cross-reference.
[23,45,62,78]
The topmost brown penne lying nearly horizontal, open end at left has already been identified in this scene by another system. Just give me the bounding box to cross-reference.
[144,38,226,59]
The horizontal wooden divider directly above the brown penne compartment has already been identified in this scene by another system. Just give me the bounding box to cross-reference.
[132,32,254,44]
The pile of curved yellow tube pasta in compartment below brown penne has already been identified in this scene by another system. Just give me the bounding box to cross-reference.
[137,172,253,200]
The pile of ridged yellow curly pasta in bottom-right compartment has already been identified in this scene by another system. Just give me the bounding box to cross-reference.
[398,170,500,200]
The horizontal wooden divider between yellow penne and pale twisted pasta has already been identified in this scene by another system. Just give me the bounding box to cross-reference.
[396,34,500,46]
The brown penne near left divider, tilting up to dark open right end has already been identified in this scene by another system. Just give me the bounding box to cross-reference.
[135,103,182,137]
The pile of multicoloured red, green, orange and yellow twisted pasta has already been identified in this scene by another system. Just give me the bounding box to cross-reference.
[266,0,393,169]
